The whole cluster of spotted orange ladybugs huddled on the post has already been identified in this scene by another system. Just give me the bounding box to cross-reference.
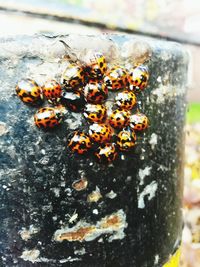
[16,52,149,163]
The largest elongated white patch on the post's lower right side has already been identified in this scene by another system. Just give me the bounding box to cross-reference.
[138,181,158,209]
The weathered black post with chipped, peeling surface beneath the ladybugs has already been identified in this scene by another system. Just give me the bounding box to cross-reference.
[0,35,187,267]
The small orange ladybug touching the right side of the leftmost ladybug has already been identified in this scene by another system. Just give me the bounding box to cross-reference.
[42,80,62,103]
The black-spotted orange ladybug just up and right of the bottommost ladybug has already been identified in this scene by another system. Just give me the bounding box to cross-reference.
[117,127,136,151]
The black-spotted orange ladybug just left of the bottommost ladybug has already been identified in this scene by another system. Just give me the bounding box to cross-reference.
[68,131,92,155]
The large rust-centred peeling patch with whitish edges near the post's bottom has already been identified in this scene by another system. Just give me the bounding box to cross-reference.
[53,209,127,242]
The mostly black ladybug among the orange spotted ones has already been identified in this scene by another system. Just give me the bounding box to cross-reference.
[61,91,85,112]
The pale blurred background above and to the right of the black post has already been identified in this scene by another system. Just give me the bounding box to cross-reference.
[0,0,200,267]
